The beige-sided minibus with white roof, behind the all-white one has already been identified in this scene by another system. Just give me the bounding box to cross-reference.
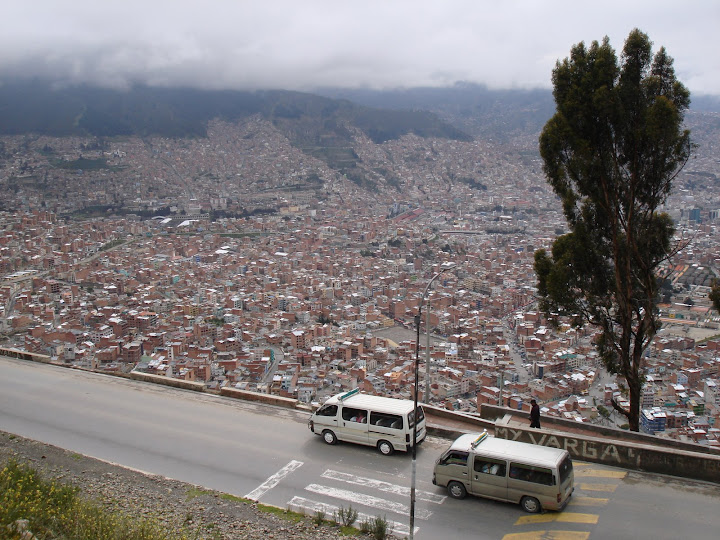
[433,432,575,513]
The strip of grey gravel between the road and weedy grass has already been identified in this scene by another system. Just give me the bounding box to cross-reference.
[0,431,354,540]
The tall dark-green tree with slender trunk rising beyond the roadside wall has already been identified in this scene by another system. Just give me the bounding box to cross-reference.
[535,29,692,431]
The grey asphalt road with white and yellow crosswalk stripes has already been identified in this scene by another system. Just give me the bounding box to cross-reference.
[0,358,720,540]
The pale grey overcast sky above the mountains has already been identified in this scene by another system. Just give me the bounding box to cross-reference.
[0,0,720,94]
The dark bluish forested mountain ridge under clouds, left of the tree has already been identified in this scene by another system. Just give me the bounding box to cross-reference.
[0,82,470,143]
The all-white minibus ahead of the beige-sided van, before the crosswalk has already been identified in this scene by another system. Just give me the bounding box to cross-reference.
[308,388,425,456]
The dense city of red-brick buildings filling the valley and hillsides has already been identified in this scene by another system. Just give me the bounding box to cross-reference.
[0,106,720,448]
